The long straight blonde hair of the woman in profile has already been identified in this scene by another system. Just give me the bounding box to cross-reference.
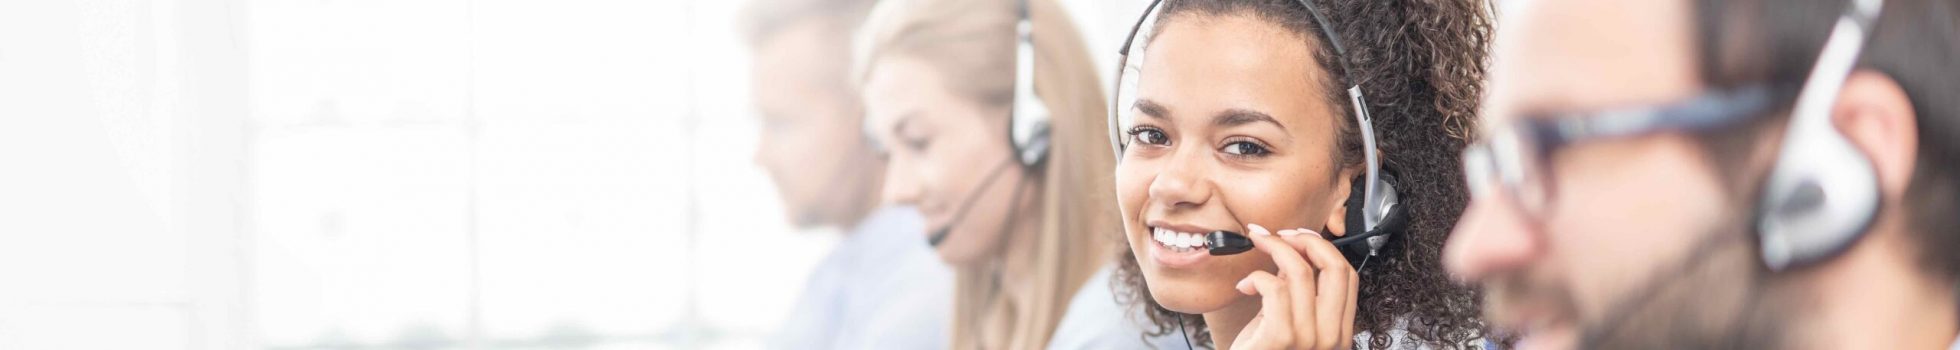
[853,0,1121,348]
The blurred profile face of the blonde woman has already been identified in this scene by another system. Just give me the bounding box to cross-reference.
[864,55,1033,266]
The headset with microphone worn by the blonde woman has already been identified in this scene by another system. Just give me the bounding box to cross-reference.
[909,0,1051,246]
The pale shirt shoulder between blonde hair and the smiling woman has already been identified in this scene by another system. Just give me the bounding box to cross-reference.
[1049,264,1186,350]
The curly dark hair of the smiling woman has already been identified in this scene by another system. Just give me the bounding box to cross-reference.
[1111,0,1492,348]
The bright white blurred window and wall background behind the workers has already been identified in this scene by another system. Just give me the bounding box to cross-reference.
[0,0,1145,350]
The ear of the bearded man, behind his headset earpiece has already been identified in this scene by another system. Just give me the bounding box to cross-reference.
[1831,68,1919,201]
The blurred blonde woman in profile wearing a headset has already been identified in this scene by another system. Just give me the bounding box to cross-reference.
[857,0,1143,348]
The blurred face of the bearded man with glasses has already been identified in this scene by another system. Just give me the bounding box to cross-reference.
[1445,0,1795,348]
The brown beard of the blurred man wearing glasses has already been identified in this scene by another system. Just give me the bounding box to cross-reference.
[1578,223,1805,348]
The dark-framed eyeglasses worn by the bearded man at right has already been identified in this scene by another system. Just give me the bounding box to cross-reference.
[1464,86,1772,219]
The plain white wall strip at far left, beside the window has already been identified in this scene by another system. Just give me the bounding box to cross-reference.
[0,0,249,348]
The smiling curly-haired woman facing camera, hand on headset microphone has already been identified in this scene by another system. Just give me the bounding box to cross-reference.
[1115,0,1490,348]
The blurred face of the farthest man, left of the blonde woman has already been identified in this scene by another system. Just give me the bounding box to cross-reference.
[751,22,884,229]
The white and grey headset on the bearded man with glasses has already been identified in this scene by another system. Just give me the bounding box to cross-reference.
[1756,0,1884,270]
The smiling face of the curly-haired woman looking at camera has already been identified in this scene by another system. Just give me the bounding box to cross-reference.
[1115,16,1350,313]
